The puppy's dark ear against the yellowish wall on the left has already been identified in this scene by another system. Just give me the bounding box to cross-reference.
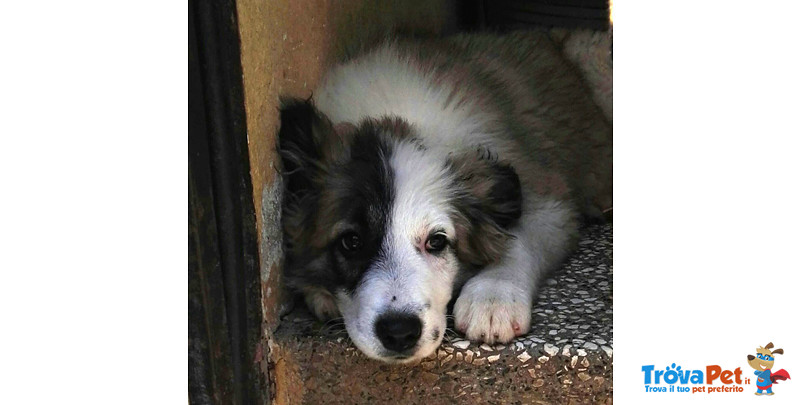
[278,98,352,195]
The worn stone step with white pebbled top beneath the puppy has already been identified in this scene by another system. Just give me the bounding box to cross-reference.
[269,224,613,405]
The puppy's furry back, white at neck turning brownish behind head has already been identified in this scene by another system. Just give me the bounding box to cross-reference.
[314,32,612,216]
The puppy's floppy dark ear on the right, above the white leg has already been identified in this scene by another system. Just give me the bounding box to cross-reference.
[448,148,522,267]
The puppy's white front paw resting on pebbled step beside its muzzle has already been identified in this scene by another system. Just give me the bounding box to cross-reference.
[453,277,533,344]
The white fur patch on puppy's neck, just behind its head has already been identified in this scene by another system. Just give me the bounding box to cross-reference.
[314,44,493,151]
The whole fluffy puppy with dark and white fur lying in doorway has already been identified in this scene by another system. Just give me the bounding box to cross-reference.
[279,32,612,362]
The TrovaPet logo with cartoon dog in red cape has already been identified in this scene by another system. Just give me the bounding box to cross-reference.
[642,343,791,395]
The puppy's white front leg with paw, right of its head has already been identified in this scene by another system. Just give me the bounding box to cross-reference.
[453,199,577,344]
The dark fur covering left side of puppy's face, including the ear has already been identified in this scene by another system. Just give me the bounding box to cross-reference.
[279,100,399,293]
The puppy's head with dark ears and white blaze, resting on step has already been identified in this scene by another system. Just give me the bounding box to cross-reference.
[279,100,521,362]
